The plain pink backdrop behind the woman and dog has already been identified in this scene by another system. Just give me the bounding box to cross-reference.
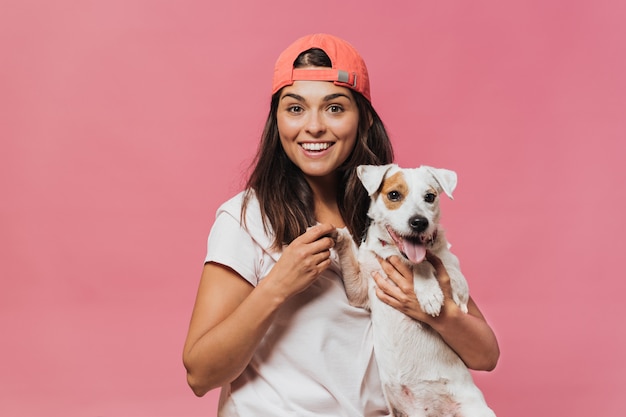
[0,0,626,417]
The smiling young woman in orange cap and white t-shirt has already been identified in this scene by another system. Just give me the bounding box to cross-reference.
[183,34,499,417]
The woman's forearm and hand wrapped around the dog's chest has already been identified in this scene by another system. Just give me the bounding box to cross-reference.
[374,254,500,371]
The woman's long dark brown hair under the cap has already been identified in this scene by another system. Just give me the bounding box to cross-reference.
[241,48,393,249]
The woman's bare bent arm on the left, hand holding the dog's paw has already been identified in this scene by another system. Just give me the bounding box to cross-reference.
[183,225,335,396]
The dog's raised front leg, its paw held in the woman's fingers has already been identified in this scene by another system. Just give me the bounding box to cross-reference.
[335,229,369,308]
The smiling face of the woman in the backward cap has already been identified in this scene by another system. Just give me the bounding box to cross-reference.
[277,81,359,184]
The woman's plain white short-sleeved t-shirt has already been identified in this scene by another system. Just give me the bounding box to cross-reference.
[206,193,389,417]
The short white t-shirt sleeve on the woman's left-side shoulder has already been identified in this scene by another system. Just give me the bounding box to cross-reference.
[205,211,263,286]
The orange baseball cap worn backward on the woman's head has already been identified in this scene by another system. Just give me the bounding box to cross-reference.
[272,33,372,101]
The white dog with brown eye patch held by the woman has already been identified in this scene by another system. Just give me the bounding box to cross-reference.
[336,164,495,417]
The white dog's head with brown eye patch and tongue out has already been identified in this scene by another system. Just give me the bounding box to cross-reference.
[357,164,457,264]
